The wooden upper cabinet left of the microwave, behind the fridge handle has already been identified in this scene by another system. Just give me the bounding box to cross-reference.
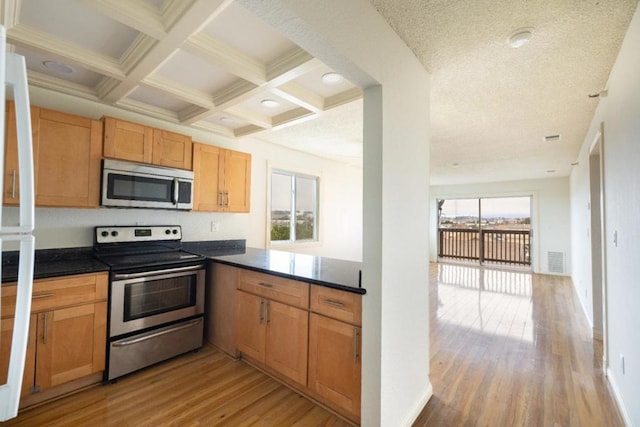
[4,102,102,208]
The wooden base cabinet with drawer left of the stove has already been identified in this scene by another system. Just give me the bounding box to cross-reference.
[0,273,107,406]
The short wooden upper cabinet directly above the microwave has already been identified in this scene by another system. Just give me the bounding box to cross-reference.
[103,117,192,170]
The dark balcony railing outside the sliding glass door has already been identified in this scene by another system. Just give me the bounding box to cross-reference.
[438,228,531,265]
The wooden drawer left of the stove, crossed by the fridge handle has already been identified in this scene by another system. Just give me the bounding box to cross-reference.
[0,273,108,317]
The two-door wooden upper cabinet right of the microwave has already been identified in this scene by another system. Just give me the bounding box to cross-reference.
[193,143,251,212]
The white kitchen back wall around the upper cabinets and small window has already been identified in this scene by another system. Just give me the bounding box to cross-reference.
[3,87,362,261]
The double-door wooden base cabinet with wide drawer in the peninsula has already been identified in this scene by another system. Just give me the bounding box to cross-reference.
[235,270,309,387]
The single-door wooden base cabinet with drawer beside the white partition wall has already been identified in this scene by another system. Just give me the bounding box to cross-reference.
[308,287,362,422]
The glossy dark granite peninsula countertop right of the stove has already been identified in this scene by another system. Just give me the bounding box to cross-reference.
[183,242,367,294]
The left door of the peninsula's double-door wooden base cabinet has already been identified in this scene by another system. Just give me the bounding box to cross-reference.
[236,291,266,363]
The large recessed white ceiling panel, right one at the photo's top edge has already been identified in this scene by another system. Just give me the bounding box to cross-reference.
[204,3,295,63]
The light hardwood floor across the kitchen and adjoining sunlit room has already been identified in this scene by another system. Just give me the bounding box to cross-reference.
[2,264,623,427]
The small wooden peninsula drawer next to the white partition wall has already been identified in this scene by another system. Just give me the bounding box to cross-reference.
[311,286,362,326]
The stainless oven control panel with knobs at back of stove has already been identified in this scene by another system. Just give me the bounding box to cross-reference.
[95,225,182,244]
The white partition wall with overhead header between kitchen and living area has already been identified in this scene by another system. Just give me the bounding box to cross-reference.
[240,0,432,427]
